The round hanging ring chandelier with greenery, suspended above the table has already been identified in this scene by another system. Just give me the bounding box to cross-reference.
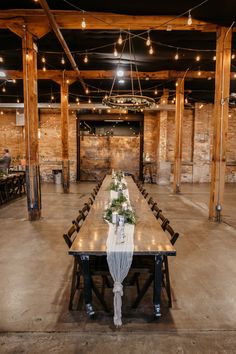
[102,32,155,112]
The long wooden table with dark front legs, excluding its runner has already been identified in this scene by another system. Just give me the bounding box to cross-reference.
[69,175,176,317]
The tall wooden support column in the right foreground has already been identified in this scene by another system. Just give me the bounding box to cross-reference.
[209,27,232,221]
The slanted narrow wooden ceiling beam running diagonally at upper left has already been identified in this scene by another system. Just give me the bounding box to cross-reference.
[39,0,86,91]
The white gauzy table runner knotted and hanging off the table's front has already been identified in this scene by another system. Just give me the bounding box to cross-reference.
[106,183,134,327]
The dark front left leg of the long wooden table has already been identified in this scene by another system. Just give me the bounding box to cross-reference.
[80,255,95,317]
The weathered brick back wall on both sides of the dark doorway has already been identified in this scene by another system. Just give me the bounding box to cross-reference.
[0,103,236,182]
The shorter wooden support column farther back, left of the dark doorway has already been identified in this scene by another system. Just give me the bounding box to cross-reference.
[60,79,70,193]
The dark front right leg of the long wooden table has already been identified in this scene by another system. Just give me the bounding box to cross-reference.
[153,254,162,318]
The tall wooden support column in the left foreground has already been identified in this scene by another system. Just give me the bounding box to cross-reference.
[22,26,41,221]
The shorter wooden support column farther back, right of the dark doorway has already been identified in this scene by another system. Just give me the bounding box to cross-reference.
[173,78,184,193]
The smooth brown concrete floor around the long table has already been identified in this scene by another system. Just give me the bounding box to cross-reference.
[0,183,236,354]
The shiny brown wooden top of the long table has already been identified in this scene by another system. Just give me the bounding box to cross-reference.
[69,175,176,256]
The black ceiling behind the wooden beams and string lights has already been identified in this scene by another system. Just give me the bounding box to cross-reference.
[0,0,236,102]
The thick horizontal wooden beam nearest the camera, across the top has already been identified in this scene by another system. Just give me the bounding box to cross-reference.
[0,9,219,32]
